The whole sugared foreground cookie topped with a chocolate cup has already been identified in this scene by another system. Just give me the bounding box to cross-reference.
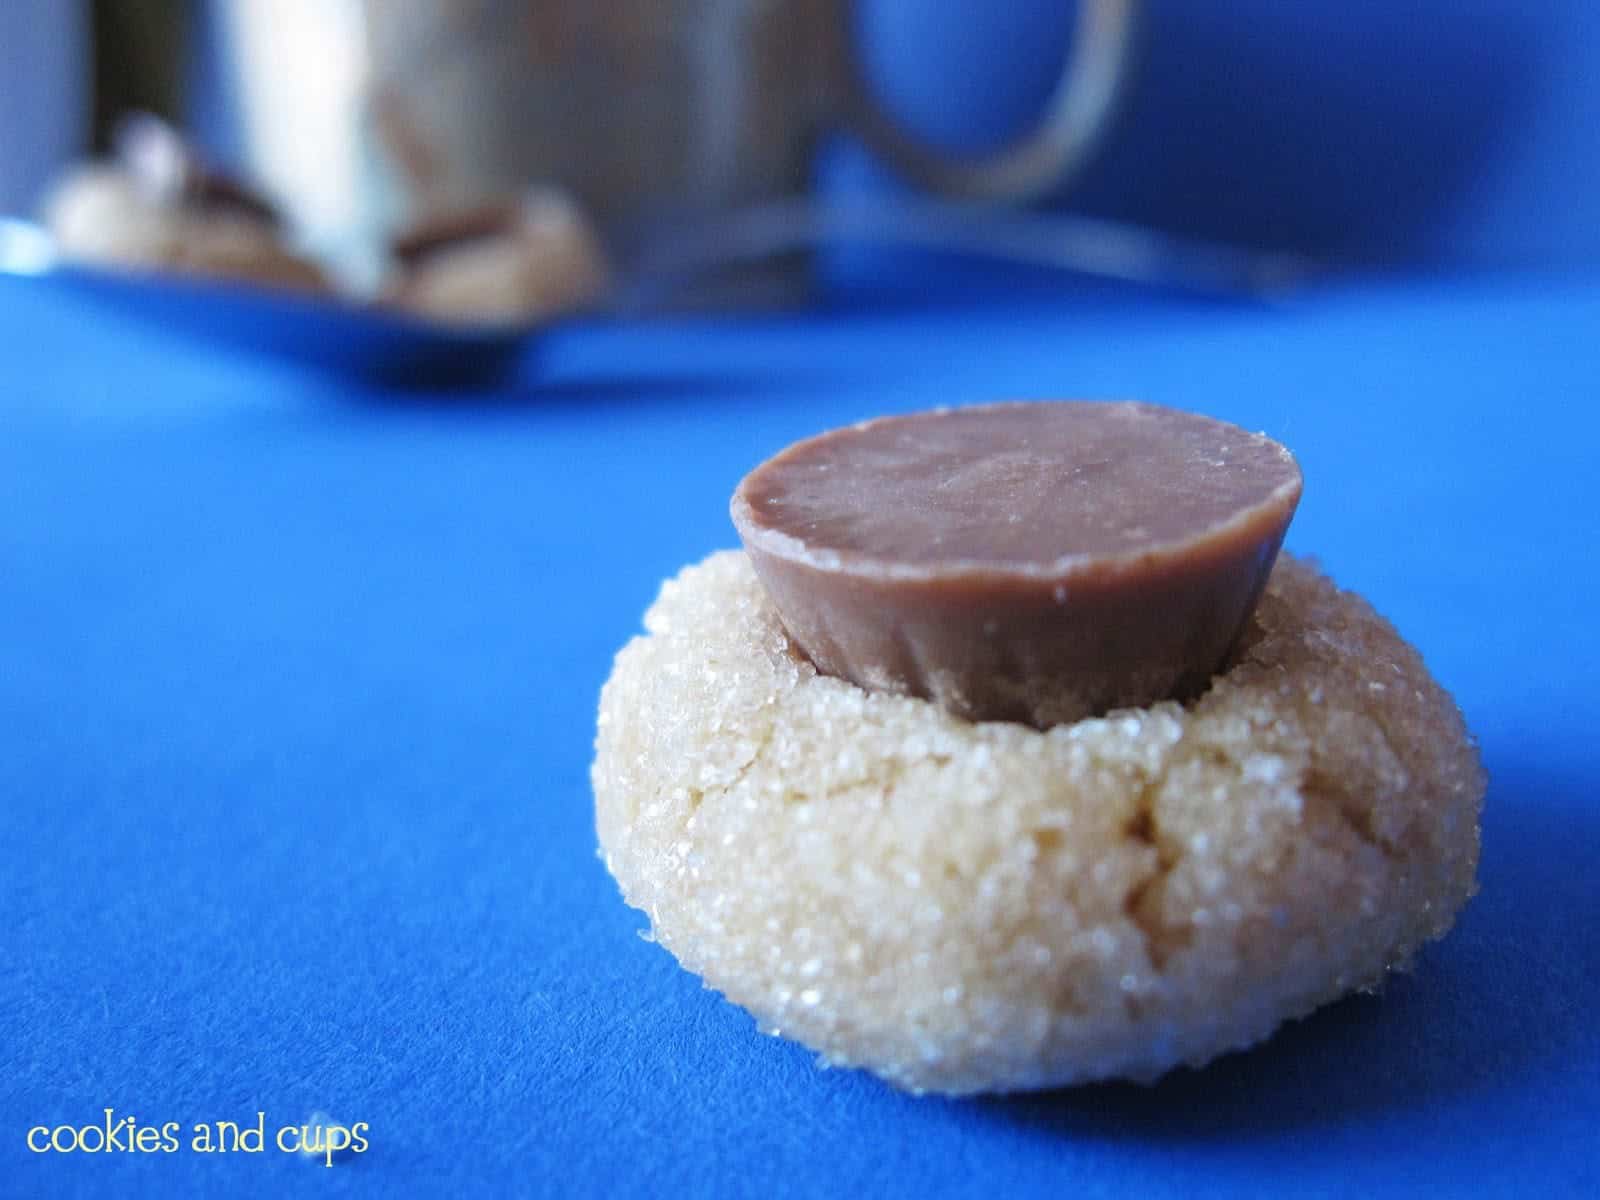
[594,403,1485,1093]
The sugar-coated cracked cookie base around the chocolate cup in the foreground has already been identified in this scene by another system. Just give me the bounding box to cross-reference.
[592,552,1485,1093]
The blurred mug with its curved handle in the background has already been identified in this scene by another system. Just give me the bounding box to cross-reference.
[216,0,1141,272]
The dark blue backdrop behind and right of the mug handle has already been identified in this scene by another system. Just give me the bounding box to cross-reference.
[851,0,1600,267]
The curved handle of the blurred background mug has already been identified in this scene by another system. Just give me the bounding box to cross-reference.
[840,0,1141,202]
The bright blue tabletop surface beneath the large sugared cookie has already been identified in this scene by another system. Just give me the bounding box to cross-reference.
[0,267,1600,1197]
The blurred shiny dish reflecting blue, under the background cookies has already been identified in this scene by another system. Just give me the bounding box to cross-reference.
[0,218,546,387]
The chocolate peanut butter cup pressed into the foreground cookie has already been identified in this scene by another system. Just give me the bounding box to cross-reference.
[731,402,1301,726]
